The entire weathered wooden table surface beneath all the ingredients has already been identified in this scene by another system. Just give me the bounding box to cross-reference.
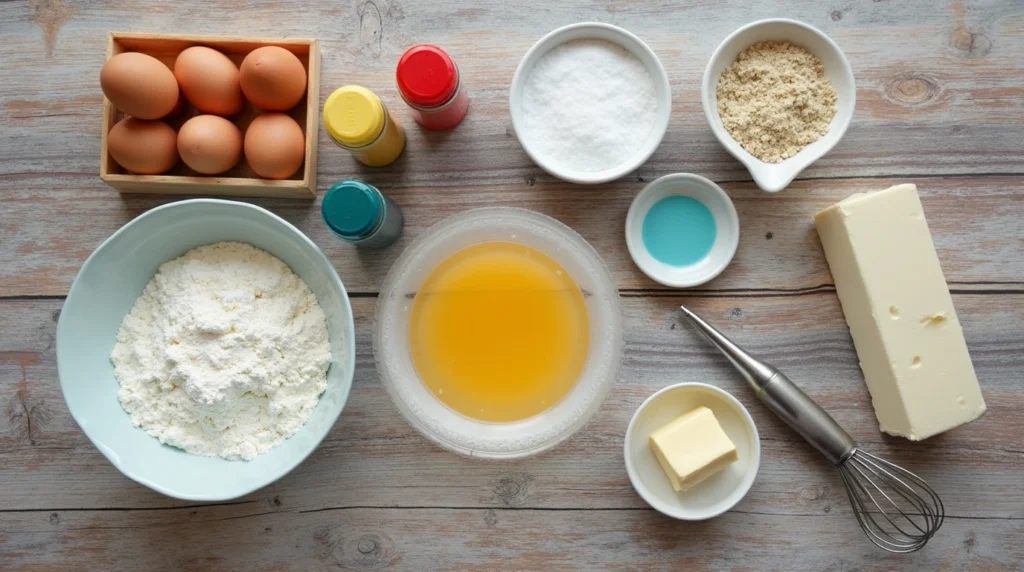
[0,0,1024,571]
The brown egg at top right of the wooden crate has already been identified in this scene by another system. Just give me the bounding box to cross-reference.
[239,46,306,112]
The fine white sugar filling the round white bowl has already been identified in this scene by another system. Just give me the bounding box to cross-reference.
[521,40,657,173]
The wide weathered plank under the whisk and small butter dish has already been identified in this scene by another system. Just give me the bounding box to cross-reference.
[0,293,1024,517]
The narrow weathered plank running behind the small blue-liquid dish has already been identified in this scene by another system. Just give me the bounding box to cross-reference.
[0,176,1024,296]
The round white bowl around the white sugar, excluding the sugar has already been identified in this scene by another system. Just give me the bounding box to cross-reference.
[509,21,672,184]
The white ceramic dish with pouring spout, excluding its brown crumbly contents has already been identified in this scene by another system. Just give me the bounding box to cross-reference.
[700,18,857,192]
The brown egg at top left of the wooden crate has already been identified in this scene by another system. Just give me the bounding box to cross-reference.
[99,51,178,119]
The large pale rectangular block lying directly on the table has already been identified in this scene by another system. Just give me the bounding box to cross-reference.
[814,184,985,441]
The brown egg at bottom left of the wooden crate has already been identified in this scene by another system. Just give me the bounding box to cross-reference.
[106,118,178,175]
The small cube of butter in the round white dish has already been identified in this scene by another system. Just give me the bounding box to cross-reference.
[649,405,737,492]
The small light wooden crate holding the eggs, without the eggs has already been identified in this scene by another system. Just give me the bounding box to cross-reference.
[99,32,319,199]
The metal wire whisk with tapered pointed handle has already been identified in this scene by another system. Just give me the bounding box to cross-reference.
[681,306,945,553]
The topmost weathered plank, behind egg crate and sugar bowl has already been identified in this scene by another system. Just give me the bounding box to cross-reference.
[0,0,1024,181]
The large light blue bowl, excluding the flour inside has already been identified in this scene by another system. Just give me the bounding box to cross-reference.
[56,199,355,501]
